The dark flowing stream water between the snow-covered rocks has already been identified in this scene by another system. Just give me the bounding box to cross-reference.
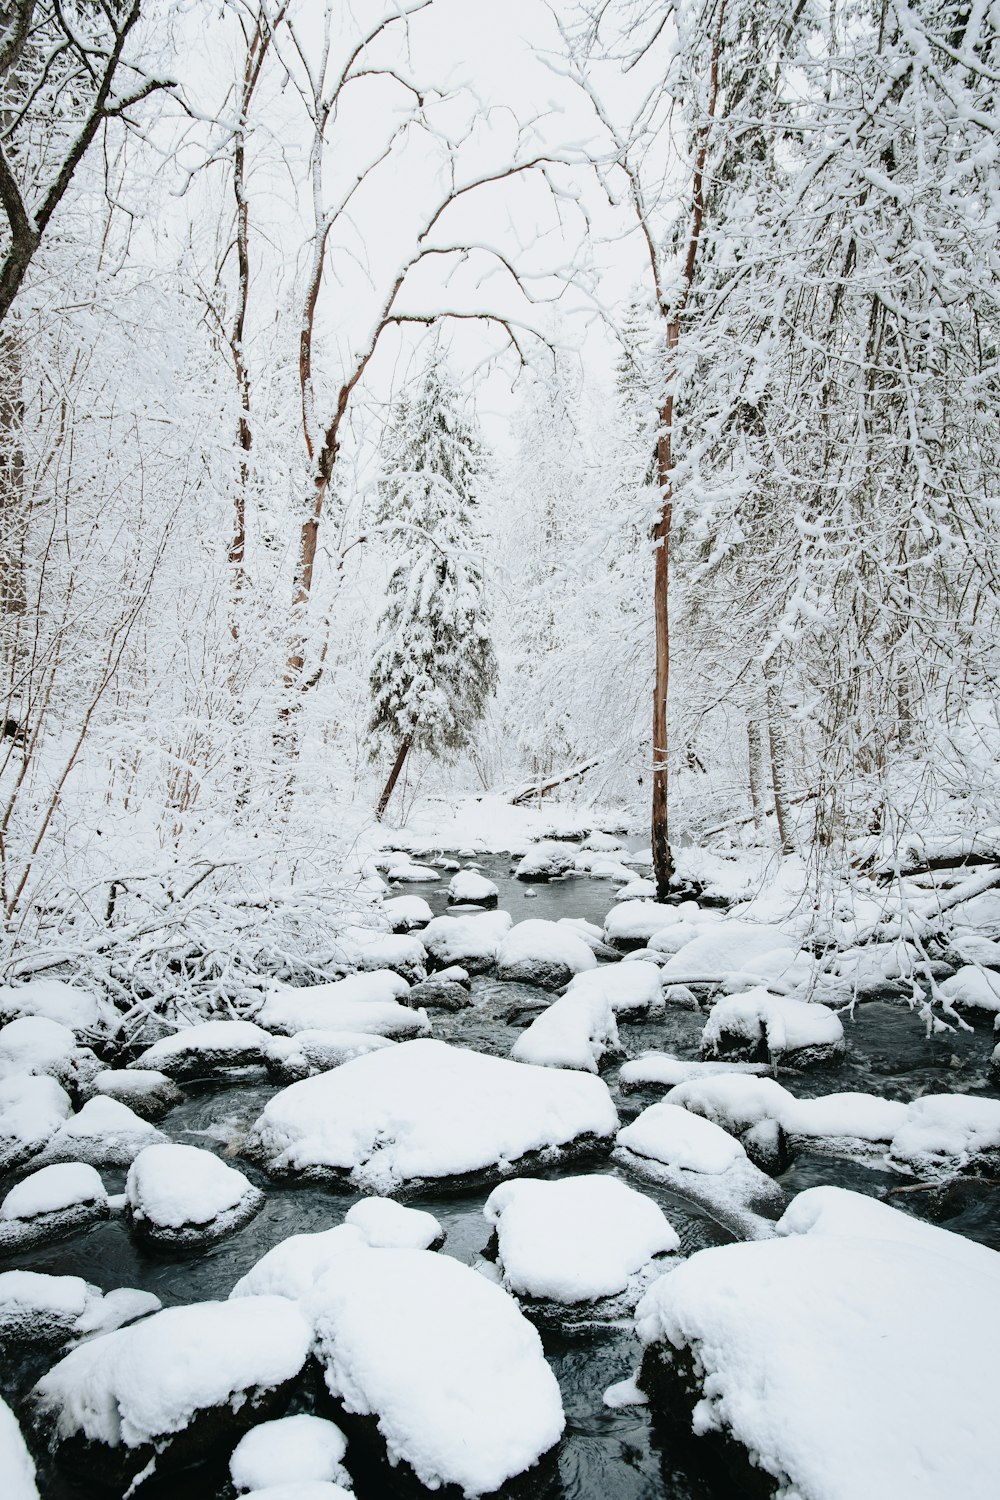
[0,858,1000,1500]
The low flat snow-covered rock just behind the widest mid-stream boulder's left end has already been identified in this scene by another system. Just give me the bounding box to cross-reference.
[256,969,430,1038]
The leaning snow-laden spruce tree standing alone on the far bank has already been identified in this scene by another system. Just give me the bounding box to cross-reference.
[369,357,496,819]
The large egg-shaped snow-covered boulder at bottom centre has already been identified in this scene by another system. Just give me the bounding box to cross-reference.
[310,1250,565,1497]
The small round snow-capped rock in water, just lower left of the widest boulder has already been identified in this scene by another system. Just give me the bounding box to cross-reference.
[124,1143,264,1250]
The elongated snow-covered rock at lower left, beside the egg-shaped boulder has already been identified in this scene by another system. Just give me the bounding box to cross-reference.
[33,1298,312,1449]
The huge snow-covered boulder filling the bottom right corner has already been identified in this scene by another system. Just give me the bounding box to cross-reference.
[636,1190,1000,1500]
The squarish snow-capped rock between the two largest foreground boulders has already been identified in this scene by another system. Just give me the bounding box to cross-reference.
[483,1175,681,1325]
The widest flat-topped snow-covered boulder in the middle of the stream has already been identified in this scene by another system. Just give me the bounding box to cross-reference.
[244,1041,618,1194]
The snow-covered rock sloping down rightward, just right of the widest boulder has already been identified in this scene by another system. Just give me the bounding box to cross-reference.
[615,1101,786,1235]
